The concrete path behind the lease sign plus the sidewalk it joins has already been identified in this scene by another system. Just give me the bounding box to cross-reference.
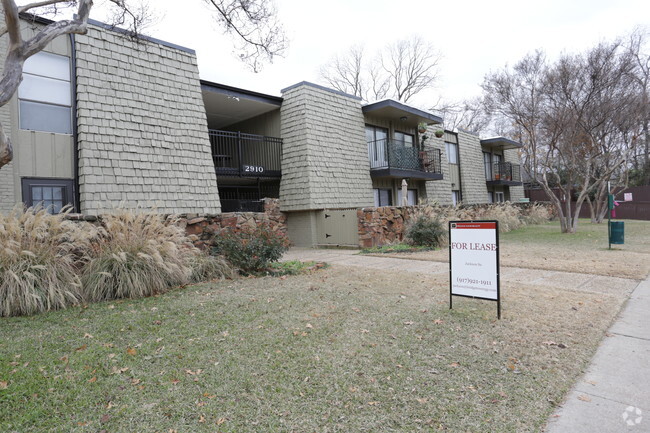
[283,248,650,433]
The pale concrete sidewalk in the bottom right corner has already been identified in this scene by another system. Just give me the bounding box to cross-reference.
[546,278,650,433]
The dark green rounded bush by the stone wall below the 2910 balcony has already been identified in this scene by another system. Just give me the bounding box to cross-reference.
[213,224,289,274]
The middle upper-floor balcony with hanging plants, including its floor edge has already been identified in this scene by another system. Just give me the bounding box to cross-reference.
[368,139,442,180]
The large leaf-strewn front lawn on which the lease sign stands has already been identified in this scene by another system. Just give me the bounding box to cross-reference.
[0,262,624,433]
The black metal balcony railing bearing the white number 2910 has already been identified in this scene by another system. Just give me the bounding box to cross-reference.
[208,130,282,177]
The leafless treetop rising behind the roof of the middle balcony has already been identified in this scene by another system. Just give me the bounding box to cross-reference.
[320,36,440,102]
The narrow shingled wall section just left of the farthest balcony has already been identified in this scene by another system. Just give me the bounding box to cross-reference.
[458,131,487,204]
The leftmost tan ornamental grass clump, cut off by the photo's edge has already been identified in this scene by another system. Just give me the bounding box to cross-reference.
[0,207,92,316]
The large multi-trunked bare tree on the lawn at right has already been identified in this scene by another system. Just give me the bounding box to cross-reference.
[483,41,641,233]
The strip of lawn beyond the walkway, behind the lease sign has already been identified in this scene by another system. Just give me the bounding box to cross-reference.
[372,220,650,280]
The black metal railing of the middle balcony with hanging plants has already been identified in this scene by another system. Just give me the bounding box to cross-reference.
[368,139,442,173]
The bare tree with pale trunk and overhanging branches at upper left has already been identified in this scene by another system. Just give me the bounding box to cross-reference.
[0,0,287,168]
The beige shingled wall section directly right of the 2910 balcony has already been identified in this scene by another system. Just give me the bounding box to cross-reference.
[280,83,374,211]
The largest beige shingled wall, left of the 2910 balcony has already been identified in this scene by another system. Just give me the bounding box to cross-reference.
[76,26,220,214]
